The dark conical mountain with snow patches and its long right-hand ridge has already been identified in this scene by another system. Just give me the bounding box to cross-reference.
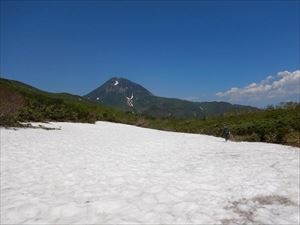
[84,77,258,118]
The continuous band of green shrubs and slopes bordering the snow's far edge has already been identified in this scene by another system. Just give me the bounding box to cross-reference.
[0,79,300,147]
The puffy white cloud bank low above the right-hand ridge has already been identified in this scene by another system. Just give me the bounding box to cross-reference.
[216,70,300,102]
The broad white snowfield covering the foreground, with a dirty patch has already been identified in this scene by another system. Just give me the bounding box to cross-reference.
[1,122,300,224]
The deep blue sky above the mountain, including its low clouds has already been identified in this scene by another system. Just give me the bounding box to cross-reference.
[1,0,300,106]
